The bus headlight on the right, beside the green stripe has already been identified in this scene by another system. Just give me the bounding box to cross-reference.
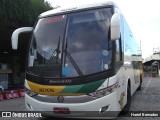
[89,82,118,98]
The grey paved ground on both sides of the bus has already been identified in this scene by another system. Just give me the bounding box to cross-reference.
[0,77,160,120]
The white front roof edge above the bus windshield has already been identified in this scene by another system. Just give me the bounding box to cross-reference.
[39,0,116,18]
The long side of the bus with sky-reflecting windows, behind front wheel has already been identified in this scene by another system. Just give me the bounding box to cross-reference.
[123,18,140,95]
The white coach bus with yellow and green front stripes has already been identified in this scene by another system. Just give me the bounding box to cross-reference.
[12,1,142,118]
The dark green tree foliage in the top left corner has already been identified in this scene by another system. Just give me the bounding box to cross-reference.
[0,0,52,26]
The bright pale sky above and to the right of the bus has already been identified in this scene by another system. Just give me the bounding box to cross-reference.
[46,0,160,59]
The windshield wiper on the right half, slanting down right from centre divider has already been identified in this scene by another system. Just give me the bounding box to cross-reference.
[64,39,83,79]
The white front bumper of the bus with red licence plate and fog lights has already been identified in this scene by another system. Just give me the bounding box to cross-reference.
[25,90,120,119]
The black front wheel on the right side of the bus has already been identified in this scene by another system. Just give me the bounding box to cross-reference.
[120,86,131,115]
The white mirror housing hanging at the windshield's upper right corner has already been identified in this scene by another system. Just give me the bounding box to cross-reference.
[110,13,120,41]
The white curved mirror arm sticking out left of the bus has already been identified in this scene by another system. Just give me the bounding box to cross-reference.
[11,27,33,50]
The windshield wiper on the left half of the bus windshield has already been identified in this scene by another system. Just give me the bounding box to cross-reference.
[39,37,61,77]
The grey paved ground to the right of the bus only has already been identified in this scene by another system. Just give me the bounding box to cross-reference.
[116,77,160,120]
